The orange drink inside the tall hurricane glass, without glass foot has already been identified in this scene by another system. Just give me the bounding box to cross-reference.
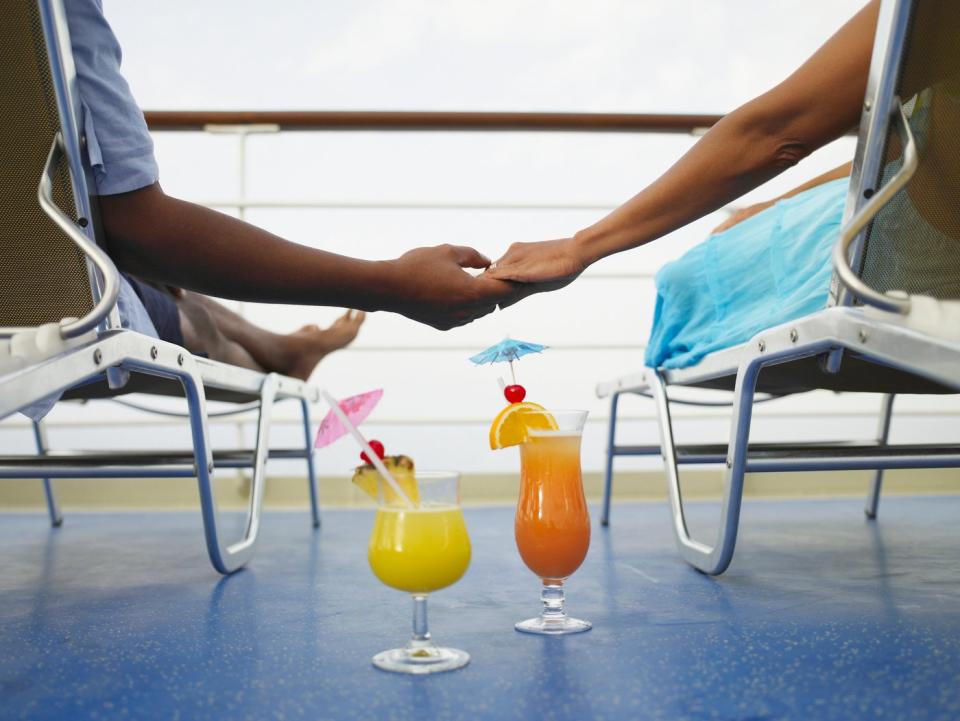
[514,431,590,582]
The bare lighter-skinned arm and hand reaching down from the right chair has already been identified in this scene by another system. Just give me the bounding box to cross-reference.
[488,0,879,289]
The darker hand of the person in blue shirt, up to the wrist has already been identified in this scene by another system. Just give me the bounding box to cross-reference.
[388,245,518,330]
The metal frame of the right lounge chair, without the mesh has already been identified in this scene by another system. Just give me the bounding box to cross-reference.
[597,0,960,574]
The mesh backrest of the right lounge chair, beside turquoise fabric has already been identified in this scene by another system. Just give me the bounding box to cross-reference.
[831,0,960,305]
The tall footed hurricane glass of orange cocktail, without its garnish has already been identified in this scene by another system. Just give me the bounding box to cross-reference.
[514,411,591,635]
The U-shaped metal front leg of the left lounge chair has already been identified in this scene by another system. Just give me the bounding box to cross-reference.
[180,372,279,574]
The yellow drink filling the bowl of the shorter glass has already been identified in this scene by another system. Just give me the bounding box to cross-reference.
[367,505,470,594]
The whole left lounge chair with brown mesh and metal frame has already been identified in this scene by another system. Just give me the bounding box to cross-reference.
[0,0,319,573]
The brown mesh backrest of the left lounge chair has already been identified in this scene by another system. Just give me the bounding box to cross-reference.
[0,0,105,335]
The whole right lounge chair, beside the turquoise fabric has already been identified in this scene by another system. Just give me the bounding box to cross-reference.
[597,0,960,574]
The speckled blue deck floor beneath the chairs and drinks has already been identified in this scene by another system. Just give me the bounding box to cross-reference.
[0,497,960,721]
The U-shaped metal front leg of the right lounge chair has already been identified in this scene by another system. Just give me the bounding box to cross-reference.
[651,365,759,575]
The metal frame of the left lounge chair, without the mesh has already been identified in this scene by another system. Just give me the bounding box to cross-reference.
[0,0,320,574]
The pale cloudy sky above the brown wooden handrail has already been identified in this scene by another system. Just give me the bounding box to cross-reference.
[104,0,863,113]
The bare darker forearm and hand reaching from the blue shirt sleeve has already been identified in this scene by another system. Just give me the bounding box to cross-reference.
[99,184,514,329]
